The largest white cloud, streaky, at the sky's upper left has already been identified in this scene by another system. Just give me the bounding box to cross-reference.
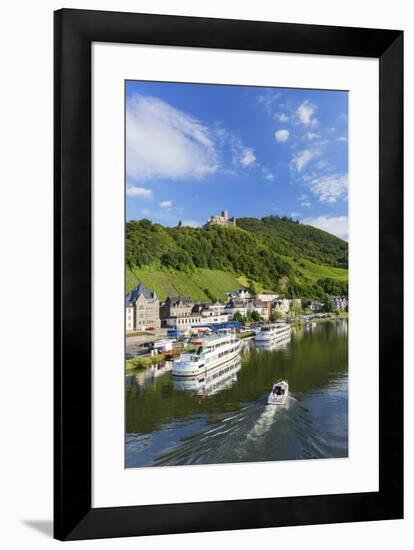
[126,94,218,180]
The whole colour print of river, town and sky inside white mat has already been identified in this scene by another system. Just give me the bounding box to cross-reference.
[124,81,348,475]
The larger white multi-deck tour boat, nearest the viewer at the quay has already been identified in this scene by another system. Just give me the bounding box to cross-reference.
[172,329,240,376]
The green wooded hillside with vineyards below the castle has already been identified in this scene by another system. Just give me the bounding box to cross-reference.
[126,216,348,300]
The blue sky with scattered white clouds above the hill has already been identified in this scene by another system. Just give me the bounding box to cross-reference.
[126,81,348,239]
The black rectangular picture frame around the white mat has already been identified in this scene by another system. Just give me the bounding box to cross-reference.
[54,9,403,540]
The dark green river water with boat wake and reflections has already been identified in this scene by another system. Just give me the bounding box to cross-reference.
[125,320,348,468]
